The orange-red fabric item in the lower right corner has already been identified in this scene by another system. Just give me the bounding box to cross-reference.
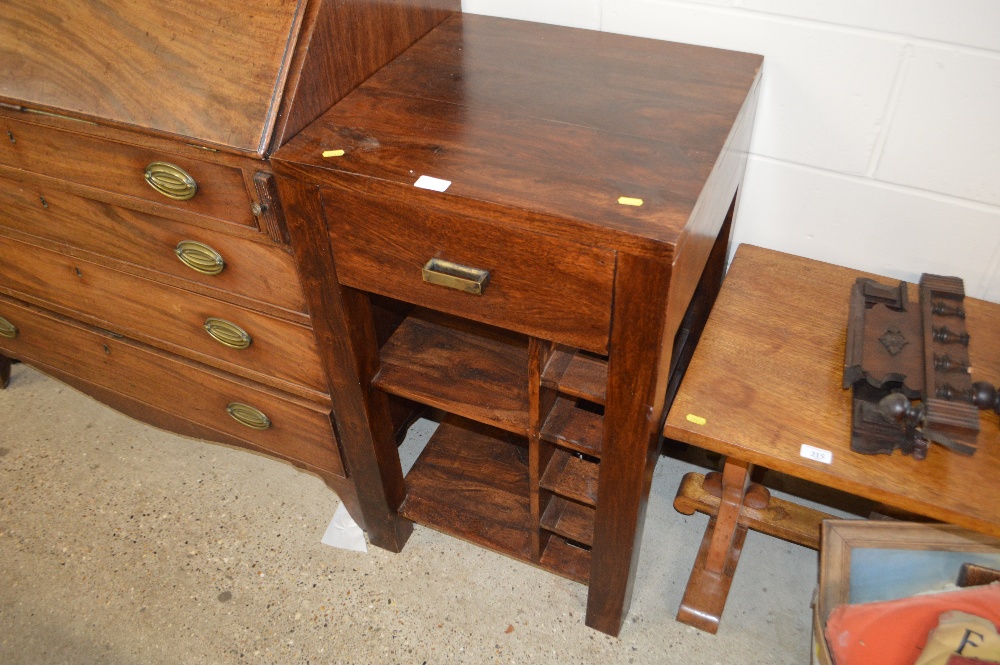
[826,583,1000,665]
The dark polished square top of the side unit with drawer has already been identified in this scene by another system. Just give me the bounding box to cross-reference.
[275,14,762,252]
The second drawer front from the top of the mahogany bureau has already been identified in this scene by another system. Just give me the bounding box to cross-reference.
[0,178,306,312]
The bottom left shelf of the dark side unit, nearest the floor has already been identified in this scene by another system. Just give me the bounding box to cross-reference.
[399,415,534,563]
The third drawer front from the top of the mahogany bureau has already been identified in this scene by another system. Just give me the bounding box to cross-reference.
[0,236,327,393]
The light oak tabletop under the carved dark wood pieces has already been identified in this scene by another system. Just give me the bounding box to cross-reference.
[664,245,1000,535]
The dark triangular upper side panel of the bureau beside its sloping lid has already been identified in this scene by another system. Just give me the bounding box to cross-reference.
[271,0,460,149]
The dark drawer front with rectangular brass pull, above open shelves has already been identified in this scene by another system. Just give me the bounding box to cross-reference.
[323,189,615,353]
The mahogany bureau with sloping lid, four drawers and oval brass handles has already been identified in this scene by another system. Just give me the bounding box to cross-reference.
[0,0,458,547]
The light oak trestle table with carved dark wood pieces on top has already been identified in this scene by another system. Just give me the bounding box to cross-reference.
[664,245,1000,633]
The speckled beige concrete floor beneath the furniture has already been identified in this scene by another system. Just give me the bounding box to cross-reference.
[0,365,817,665]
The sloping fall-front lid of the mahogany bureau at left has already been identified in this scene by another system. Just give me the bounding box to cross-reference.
[0,0,307,150]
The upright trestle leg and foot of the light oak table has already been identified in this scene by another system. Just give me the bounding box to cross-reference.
[677,458,753,633]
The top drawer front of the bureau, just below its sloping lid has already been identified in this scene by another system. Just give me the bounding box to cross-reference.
[0,118,257,227]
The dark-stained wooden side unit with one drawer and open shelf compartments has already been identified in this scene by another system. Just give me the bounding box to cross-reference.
[275,15,761,635]
